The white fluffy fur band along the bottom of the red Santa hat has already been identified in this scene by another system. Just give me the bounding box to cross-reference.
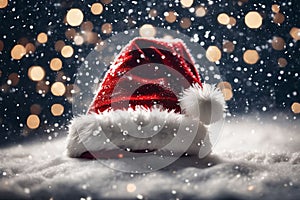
[67,107,211,157]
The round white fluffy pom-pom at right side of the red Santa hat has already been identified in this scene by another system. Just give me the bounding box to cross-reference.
[179,84,225,124]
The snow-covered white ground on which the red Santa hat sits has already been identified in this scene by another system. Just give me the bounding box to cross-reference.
[0,118,300,200]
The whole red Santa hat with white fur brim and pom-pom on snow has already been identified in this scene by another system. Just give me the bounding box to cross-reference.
[67,38,225,158]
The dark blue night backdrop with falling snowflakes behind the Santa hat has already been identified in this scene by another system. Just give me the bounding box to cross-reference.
[0,0,300,146]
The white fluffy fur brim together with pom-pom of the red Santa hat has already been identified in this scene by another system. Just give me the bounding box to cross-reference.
[66,84,225,157]
